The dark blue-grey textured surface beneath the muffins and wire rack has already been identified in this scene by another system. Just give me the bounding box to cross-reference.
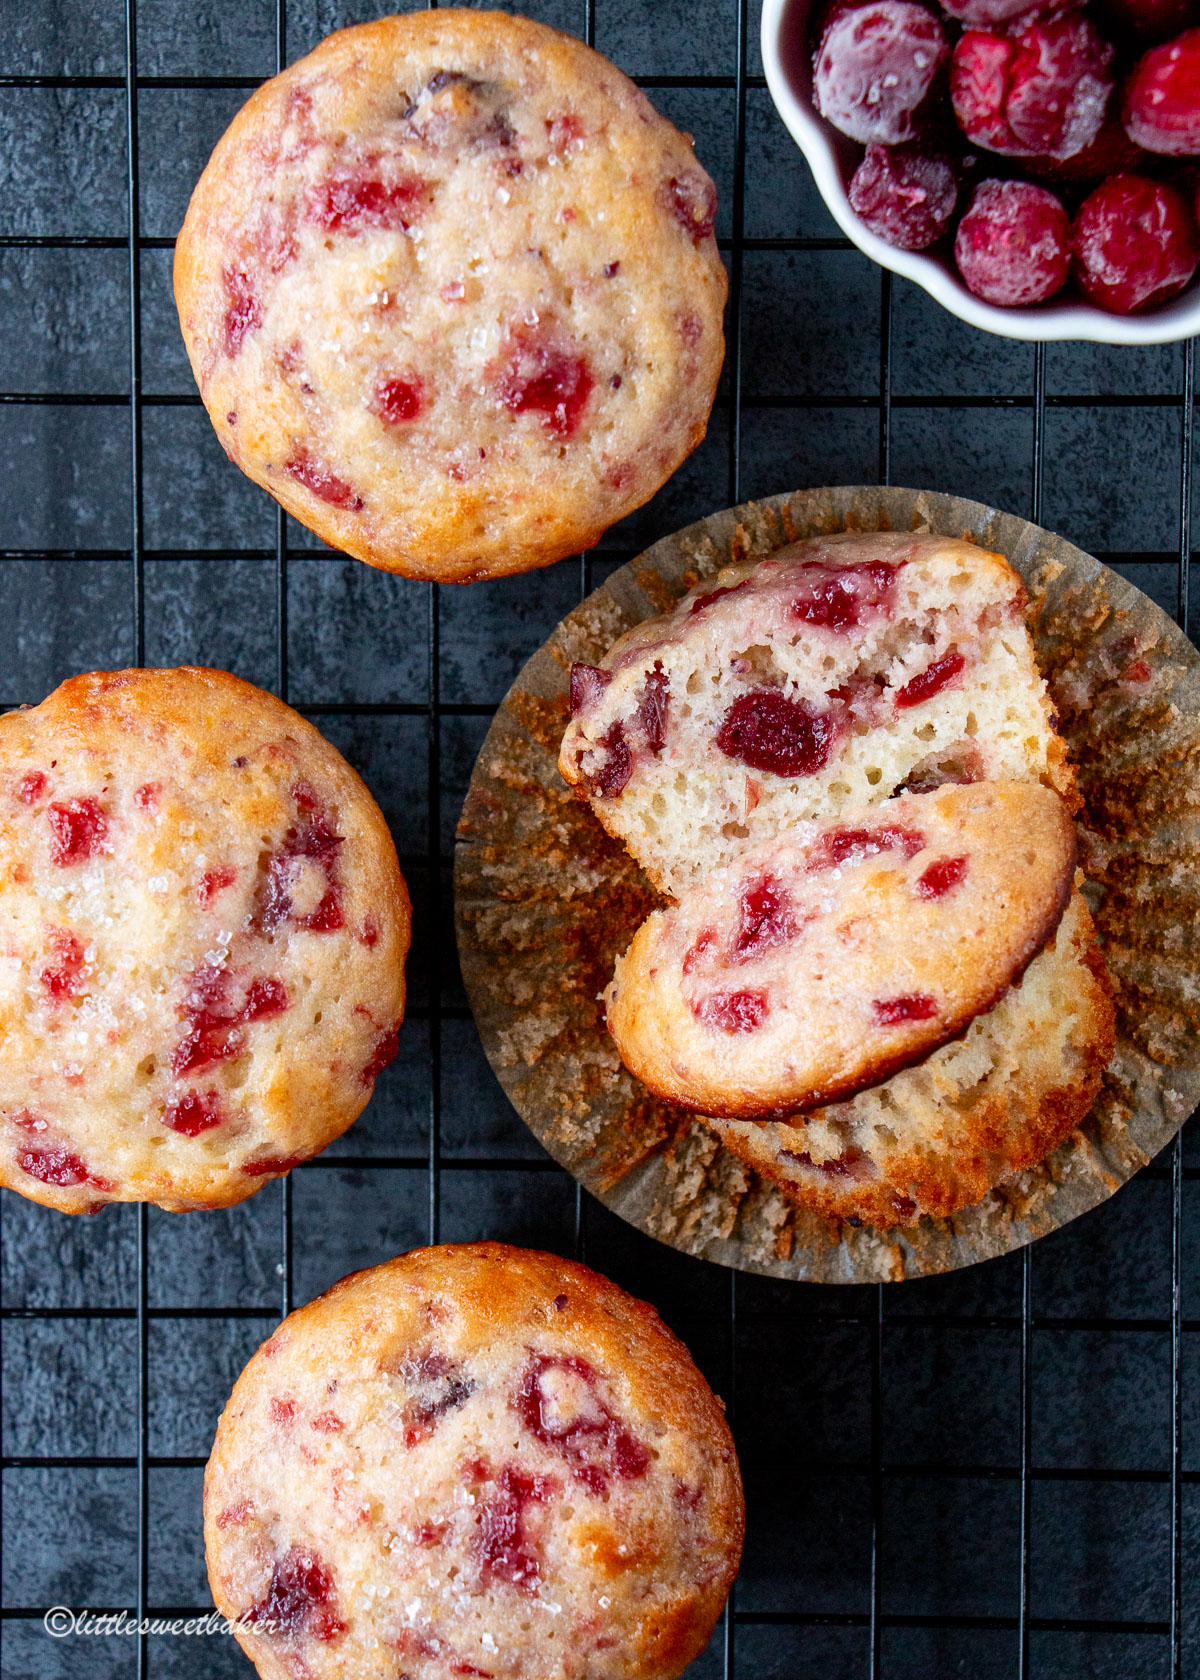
[0,0,1200,1680]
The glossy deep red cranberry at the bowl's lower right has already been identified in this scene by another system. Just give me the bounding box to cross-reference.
[1072,175,1200,314]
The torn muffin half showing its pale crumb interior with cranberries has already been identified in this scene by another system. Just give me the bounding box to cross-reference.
[560,533,1074,895]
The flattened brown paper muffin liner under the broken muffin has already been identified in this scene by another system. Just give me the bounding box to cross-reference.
[454,487,1200,1284]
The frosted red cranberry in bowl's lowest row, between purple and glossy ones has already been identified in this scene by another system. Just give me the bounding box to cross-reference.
[947,181,1071,307]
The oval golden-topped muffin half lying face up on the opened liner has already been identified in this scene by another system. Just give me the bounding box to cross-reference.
[605,781,1076,1121]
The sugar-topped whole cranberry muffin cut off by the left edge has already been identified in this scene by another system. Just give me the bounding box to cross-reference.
[0,669,408,1213]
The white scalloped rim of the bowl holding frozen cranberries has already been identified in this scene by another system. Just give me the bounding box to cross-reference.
[763,0,1200,344]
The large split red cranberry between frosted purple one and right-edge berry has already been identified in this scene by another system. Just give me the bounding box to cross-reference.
[950,12,1113,158]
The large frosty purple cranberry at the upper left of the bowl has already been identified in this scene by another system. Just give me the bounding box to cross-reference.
[812,0,950,146]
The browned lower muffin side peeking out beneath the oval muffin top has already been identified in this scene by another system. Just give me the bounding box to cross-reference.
[704,892,1114,1230]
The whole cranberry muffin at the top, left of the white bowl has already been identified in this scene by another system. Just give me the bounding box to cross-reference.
[175,8,726,583]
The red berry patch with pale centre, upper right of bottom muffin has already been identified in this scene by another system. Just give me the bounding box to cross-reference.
[514,1354,650,1495]
